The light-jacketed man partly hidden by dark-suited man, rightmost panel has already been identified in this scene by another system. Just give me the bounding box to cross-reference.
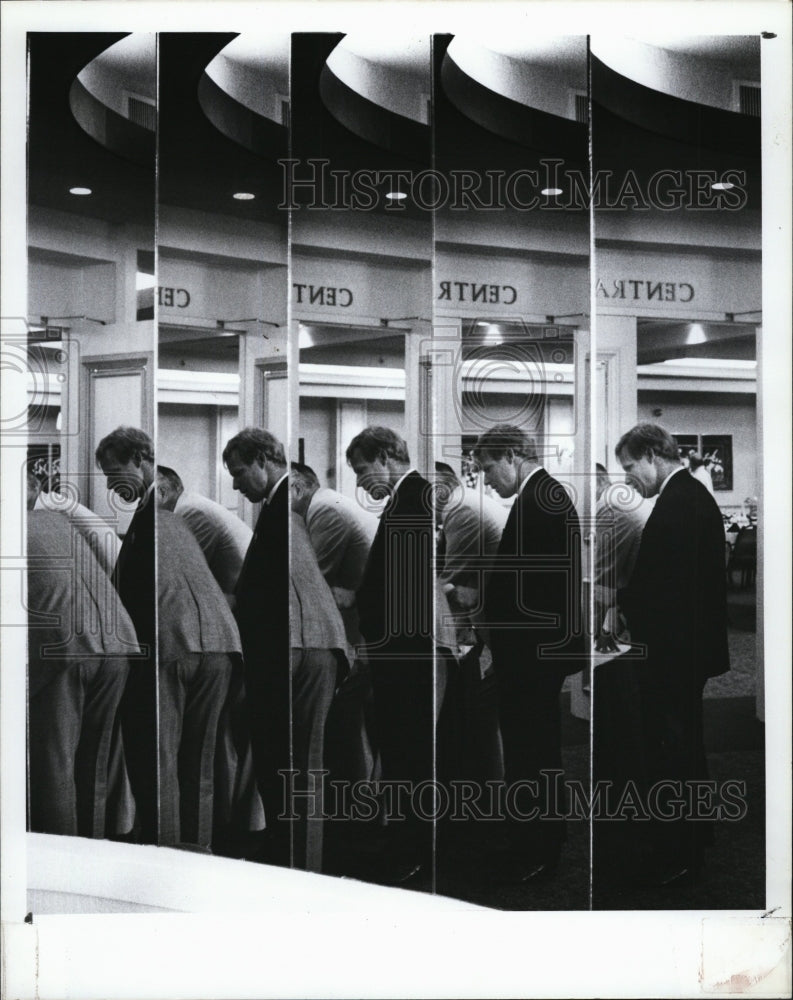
[594,463,653,649]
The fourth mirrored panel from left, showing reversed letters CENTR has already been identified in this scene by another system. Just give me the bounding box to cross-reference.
[432,31,592,909]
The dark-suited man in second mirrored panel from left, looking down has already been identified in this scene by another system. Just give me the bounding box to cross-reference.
[223,427,291,865]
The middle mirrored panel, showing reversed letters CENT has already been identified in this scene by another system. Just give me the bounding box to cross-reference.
[285,31,440,890]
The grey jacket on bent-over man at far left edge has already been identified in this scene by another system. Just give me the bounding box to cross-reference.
[27,510,138,694]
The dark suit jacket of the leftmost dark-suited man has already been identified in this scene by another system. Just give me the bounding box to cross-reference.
[113,489,157,659]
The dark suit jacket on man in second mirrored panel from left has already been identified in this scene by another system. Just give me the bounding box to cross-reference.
[234,479,290,664]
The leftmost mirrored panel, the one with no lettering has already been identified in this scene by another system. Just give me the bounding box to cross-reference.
[25,32,157,843]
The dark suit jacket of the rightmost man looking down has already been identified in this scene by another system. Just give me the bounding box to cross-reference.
[620,469,730,681]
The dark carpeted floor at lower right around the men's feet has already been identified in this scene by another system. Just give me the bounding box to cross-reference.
[326,588,765,910]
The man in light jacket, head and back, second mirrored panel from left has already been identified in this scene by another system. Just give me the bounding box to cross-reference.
[157,465,252,595]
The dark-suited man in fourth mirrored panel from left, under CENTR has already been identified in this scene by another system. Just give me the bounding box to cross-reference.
[474,424,583,882]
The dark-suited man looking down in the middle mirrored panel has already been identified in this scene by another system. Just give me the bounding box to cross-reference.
[347,427,435,884]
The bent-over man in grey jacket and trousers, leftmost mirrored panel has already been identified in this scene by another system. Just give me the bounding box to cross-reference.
[27,476,138,837]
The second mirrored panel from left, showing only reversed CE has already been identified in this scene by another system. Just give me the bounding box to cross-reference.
[156,32,290,865]
